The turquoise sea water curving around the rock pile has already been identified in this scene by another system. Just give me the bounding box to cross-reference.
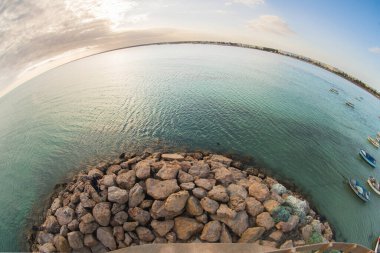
[0,45,380,251]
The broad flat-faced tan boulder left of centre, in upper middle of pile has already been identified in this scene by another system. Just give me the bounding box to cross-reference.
[146,178,179,199]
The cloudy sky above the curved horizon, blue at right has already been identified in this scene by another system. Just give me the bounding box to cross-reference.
[0,0,380,97]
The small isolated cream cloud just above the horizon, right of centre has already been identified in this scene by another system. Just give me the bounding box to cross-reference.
[248,15,295,35]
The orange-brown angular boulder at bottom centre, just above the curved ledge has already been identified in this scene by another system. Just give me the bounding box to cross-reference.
[174,217,203,240]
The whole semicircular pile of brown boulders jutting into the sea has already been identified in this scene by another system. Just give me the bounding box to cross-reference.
[29,153,333,253]
